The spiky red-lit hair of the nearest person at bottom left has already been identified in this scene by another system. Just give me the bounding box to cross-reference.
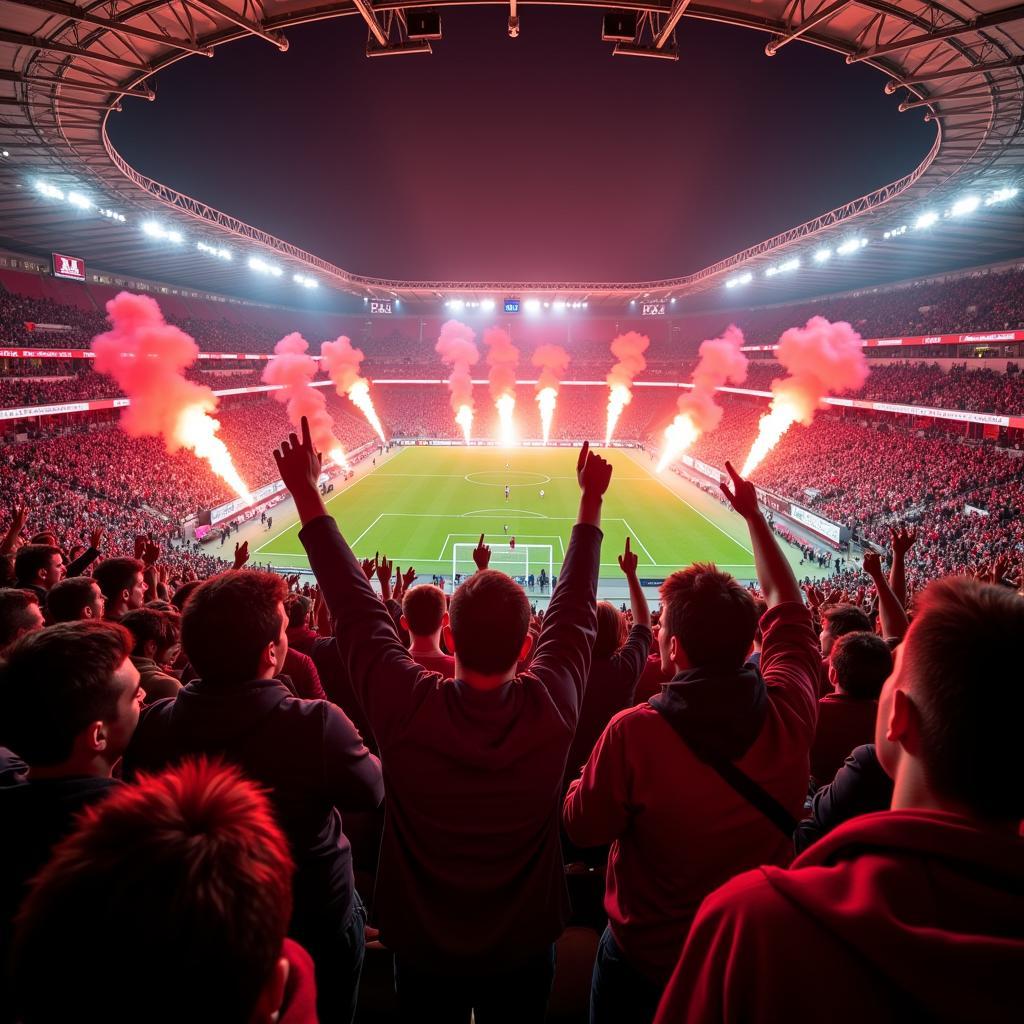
[12,761,294,1024]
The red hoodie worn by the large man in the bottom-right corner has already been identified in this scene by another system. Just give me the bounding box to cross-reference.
[656,810,1024,1024]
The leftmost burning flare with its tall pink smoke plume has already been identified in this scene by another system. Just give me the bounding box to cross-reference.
[92,292,253,505]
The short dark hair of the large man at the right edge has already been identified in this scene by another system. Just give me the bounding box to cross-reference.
[902,577,1024,821]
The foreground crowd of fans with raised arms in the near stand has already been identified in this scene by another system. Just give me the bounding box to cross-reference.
[0,419,1024,1024]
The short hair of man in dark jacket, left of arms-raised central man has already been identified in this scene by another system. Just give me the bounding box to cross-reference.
[181,569,288,683]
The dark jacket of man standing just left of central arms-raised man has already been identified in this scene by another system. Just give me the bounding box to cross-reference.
[124,679,384,937]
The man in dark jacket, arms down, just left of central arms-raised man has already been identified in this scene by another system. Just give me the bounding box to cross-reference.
[125,570,382,1021]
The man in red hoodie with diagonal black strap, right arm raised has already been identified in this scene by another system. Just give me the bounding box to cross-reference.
[563,463,820,1024]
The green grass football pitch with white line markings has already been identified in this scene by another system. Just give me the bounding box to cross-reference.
[255,447,782,580]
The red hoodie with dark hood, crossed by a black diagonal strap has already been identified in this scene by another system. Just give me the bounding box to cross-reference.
[563,602,820,984]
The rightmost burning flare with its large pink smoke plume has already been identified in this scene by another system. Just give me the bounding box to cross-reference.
[739,316,870,476]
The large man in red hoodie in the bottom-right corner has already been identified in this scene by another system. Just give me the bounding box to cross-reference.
[658,579,1024,1024]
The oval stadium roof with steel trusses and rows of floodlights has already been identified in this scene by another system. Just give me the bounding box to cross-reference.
[0,0,1024,305]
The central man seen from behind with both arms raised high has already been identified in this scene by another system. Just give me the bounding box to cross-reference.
[275,419,611,1022]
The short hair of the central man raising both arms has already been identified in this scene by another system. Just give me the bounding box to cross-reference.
[450,569,529,676]
